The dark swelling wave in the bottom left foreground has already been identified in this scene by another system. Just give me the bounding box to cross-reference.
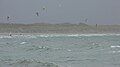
[1,59,58,67]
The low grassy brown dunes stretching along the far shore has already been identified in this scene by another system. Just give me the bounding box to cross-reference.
[0,23,120,35]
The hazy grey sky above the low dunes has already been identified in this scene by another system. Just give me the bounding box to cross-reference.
[0,0,120,24]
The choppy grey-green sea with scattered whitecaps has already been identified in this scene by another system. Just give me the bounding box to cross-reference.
[0,34,120,67]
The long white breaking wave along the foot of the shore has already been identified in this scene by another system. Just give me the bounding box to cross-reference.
[0,34,120,38]
